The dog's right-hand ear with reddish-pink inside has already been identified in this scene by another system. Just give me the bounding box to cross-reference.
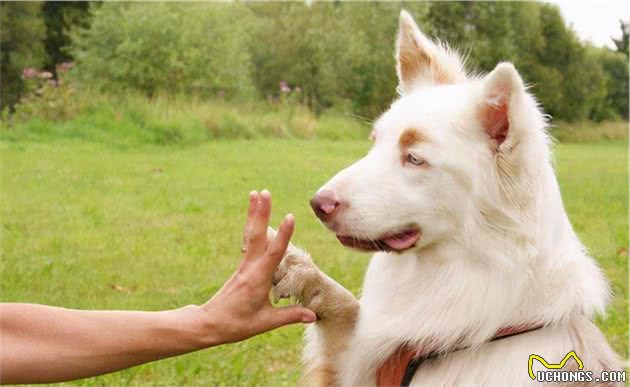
[479,62,525,151]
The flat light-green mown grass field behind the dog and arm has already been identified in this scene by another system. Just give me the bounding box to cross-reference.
[0,139,628,386]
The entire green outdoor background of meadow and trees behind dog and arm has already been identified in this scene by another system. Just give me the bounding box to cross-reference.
[0,1,630,386]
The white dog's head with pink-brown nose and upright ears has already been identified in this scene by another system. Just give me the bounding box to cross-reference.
[311,11,547,252]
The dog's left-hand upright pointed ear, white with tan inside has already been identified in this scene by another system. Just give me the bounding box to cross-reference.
[396,10,466,94]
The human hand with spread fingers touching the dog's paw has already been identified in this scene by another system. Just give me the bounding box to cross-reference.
[198,191,316,345]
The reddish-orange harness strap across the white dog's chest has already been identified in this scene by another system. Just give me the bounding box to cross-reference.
[376,324,543,387]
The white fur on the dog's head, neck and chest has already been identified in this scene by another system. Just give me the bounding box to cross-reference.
[282,9,614,386]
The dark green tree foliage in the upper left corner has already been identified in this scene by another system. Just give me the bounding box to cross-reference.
[0,1,46,108]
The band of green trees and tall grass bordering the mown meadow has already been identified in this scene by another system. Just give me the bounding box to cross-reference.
[2,2,630,143]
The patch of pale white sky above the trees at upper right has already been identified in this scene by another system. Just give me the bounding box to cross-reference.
[548,0,630,48]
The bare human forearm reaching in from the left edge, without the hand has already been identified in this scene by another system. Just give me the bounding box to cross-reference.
[0,304,212,383]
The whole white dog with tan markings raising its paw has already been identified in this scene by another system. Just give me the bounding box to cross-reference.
[274,11,620,386]
